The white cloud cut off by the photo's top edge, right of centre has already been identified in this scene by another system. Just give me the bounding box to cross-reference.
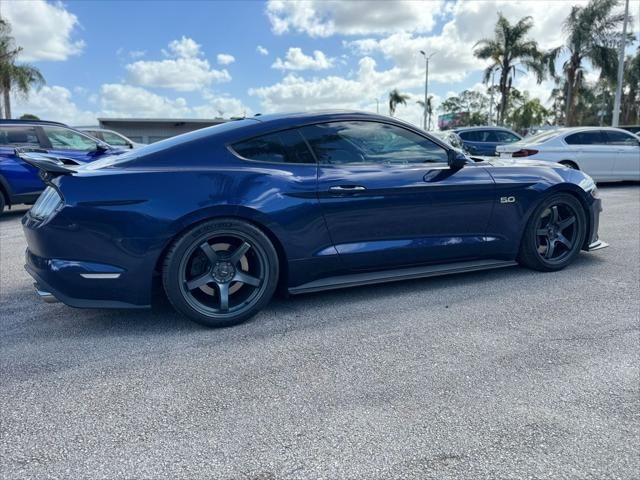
[266,0,445,37]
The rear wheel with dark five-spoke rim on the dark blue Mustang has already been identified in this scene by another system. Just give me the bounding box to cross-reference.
[162,219,279,327]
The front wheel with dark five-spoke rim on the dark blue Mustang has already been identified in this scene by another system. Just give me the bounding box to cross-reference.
[518,193,587,272]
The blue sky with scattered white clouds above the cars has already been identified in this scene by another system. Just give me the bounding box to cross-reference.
[0,0,640,128]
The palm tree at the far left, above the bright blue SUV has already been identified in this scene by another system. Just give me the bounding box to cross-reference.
[0,19,44,118]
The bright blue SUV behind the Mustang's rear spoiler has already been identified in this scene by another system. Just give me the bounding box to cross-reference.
[0,120,123,215]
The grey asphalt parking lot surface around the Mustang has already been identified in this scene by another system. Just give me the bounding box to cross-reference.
[0,185,640,480]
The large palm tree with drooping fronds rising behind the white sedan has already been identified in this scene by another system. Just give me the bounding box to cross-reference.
[546,0,624,126]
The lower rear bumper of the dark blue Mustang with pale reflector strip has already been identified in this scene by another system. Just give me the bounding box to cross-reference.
[24,249,150,308]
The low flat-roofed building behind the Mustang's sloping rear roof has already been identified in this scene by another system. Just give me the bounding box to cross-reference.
[98,118,228,143]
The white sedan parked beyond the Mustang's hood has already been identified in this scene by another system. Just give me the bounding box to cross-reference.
[497,127,640,182]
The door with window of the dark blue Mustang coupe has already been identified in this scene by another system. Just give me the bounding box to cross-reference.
[301,121,494,270]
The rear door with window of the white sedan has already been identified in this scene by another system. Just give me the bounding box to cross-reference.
[564,130,617,181]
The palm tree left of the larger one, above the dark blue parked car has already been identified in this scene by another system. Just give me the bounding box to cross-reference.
[473,13,545,124]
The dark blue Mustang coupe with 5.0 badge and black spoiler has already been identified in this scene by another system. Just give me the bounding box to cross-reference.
[20,112,606,326]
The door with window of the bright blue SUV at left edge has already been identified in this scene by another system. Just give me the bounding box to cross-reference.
[0,125,44,201]
